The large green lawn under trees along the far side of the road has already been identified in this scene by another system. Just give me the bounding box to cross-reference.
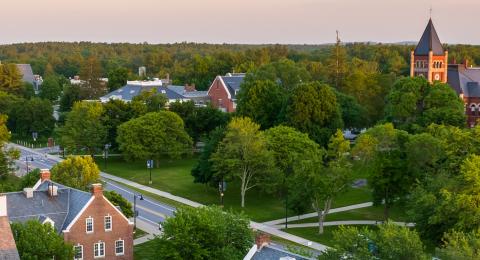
[98,157,371,222]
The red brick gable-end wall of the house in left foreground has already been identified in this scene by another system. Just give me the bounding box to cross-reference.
[64,191,133,259]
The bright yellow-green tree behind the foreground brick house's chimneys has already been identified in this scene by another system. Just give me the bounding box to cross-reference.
[51,156,100,191]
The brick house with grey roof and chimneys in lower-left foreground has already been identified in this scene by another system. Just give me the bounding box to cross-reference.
[0,170,133,260]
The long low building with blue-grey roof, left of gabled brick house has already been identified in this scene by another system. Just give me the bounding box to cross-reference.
[100,79,209,106]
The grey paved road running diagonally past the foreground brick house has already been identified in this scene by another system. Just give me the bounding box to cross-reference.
[11,145,175,231]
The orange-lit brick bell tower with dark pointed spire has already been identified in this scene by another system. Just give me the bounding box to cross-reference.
[410,18,448,83]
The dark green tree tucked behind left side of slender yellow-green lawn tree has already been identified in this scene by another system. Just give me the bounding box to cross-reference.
[191,127,225,186]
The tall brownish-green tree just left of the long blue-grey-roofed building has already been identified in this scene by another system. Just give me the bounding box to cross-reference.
[79,56,106,100]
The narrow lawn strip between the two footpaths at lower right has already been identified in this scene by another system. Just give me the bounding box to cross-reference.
[288,206,408,224]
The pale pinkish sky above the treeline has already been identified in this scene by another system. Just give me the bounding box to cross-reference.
[0,0,480,44]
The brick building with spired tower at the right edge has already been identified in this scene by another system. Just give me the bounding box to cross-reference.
[410,19,480,127]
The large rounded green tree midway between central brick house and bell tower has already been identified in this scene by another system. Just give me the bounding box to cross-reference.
[287,82,343,145]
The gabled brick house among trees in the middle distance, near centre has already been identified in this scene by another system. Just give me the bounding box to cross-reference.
[208,73,245,113]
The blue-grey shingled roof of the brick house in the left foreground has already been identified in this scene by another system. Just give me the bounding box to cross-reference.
[5,181,92,232]
